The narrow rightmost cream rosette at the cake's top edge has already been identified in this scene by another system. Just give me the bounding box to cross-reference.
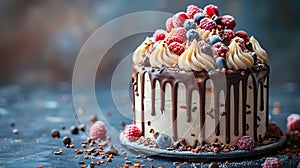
[250,36,269,64]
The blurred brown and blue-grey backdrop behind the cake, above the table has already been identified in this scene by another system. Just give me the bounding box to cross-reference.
[0,0,300,86]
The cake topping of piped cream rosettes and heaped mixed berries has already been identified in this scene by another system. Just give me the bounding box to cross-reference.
[132,4,269,71]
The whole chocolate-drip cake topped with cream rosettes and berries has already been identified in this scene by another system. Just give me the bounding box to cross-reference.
[125,5,270,149]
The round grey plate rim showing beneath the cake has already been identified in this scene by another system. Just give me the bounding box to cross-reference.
[119,133,286,160]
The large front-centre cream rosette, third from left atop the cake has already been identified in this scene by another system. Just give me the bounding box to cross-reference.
[178,40,214,71]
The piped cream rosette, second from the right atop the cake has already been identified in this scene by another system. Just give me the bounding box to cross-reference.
[226,40,254,70]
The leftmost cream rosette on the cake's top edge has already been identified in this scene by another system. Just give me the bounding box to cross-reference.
[132,37,154,65]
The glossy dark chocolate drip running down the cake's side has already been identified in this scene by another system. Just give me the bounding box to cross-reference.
[132,65,269,144]
